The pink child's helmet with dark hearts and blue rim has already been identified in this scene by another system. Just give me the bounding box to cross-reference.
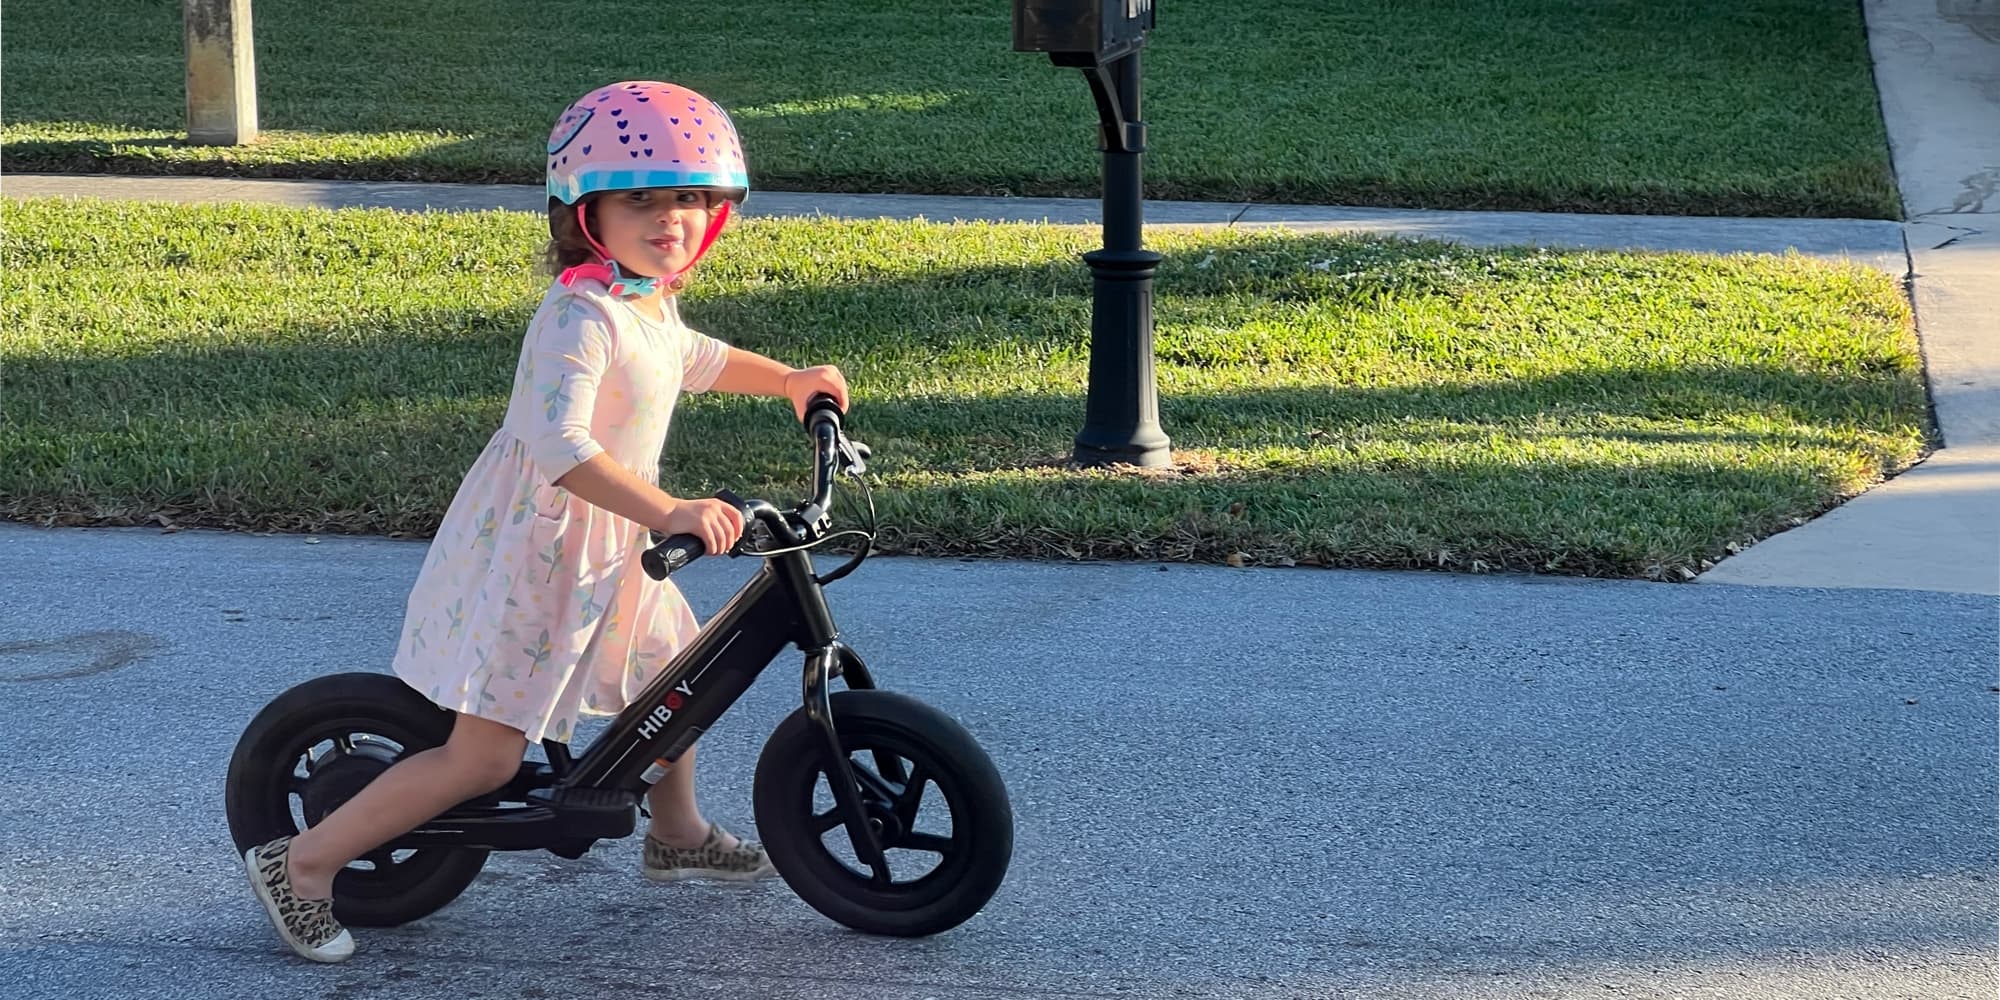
[548,80,750,288]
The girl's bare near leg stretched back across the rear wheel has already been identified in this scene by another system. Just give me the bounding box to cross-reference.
[288,714,528,900]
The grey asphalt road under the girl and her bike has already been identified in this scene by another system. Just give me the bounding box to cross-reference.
[0,526,2000,1000]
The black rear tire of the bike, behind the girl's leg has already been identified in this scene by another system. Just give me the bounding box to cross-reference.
[224,674,488,928]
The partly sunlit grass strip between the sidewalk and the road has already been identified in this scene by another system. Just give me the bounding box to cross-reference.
[0,200,1926,578]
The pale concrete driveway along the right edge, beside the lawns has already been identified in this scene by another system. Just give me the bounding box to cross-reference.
[1702,0,2000,594]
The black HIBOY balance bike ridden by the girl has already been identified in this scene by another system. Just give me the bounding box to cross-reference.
[226,396,1014,936]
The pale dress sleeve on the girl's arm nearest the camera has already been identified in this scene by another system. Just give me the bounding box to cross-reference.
[526,296,614,482]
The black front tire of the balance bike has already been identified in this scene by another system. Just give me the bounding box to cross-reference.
[754,690,1014,938]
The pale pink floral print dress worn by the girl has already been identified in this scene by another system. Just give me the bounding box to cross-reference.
[394,280,728,742]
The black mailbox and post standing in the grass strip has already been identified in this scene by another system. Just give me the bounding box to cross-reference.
[1014,0,1170,468]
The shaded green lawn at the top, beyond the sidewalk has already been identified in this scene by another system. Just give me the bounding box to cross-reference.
[0,0,1900,218]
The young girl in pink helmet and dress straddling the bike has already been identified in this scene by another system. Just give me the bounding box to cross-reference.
[244,82,848,962]
